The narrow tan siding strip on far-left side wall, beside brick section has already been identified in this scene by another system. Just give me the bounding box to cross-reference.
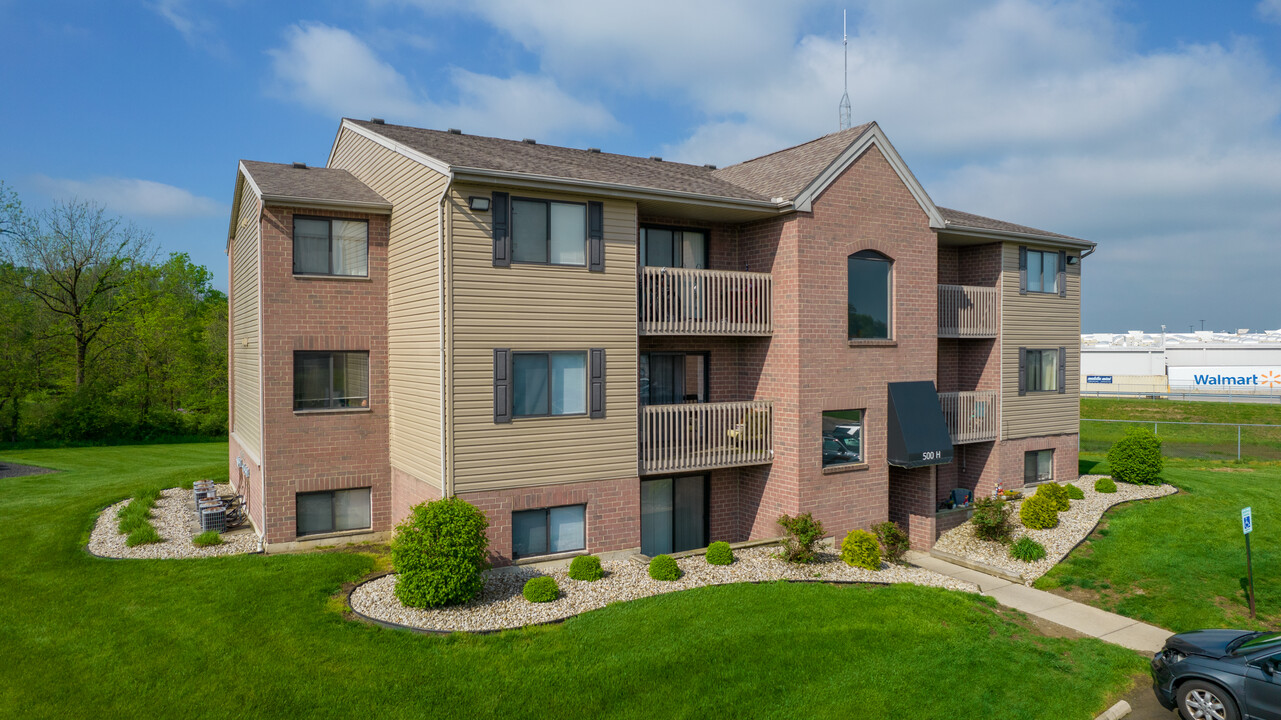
[231,182,263,459]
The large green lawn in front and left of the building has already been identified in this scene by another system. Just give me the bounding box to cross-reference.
[0,445,1142,719]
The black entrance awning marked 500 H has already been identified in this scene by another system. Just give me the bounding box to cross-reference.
[889,380,952,468]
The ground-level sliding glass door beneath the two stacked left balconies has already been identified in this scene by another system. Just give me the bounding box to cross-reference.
[641,475,707,557]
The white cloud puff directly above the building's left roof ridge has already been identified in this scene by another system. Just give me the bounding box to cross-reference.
[269,23,617,140]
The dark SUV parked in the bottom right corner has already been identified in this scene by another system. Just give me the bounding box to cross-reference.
[1152,630,1281,720]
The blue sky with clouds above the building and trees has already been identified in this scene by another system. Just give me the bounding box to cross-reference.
[0,0,1281,332]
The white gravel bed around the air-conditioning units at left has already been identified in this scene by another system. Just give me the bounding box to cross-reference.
[88,484,257,560]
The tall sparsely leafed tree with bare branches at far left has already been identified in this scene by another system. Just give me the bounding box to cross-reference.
[0,193,155,388]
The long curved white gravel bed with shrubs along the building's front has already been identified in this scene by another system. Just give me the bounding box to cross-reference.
[351,547,979,630]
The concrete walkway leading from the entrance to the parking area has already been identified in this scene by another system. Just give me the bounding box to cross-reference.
[907,552,1171,655]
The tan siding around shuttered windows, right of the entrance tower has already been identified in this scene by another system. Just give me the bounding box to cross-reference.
[1000,242,1081,439]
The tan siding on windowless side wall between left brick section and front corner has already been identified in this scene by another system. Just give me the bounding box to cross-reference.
[329,129,447,489]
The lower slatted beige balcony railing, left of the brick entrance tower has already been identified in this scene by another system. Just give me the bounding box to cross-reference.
[641,400,774,475]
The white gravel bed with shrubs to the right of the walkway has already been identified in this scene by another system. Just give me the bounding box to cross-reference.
[934,475,1177,585]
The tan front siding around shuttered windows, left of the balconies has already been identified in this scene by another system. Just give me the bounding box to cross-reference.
[448,181,637,492]
